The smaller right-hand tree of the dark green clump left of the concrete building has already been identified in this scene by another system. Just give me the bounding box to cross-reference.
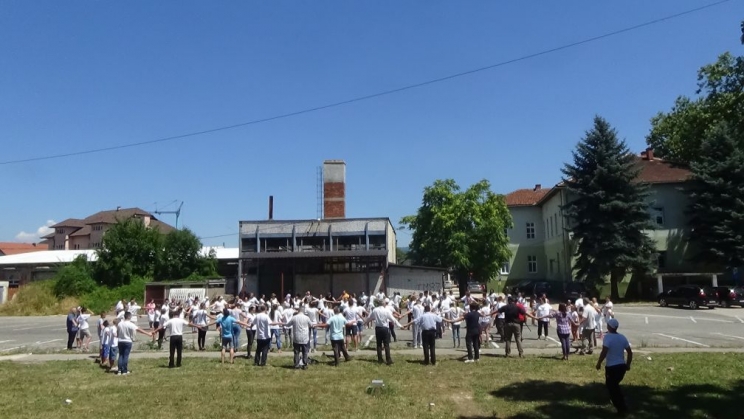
[155,228,202,279]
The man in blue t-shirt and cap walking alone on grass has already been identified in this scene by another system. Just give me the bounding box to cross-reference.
[597,319,633,415]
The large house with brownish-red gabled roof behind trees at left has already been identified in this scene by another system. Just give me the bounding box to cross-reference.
[43,208,174,250]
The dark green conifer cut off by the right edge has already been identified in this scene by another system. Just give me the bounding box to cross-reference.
[690,124,744,269]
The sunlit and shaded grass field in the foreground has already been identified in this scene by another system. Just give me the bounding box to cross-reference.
[0,354,744,419]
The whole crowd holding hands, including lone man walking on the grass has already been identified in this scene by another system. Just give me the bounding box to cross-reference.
[67,291,632,411]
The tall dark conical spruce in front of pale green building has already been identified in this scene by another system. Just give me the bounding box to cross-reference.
[562,117,655,299]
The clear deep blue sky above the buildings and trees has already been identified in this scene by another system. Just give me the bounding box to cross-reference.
[0,0,744,246]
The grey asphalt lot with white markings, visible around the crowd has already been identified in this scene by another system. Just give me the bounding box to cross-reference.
[0,305,744,355]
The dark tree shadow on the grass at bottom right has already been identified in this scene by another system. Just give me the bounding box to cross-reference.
[460,380,744,419]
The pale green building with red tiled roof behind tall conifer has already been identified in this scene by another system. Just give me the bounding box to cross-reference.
[501,150,694,296]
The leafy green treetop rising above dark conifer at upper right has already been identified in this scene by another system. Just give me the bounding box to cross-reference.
[646,52,744,163]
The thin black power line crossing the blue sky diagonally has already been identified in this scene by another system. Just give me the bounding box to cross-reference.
[0,0,732,166]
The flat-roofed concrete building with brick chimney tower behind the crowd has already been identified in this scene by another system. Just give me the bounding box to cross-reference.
[238,160,396,297]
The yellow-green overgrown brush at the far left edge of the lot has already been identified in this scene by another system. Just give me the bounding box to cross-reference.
[0,280,78,316]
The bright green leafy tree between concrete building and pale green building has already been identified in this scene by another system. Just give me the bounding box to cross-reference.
[400,179,512,281]
